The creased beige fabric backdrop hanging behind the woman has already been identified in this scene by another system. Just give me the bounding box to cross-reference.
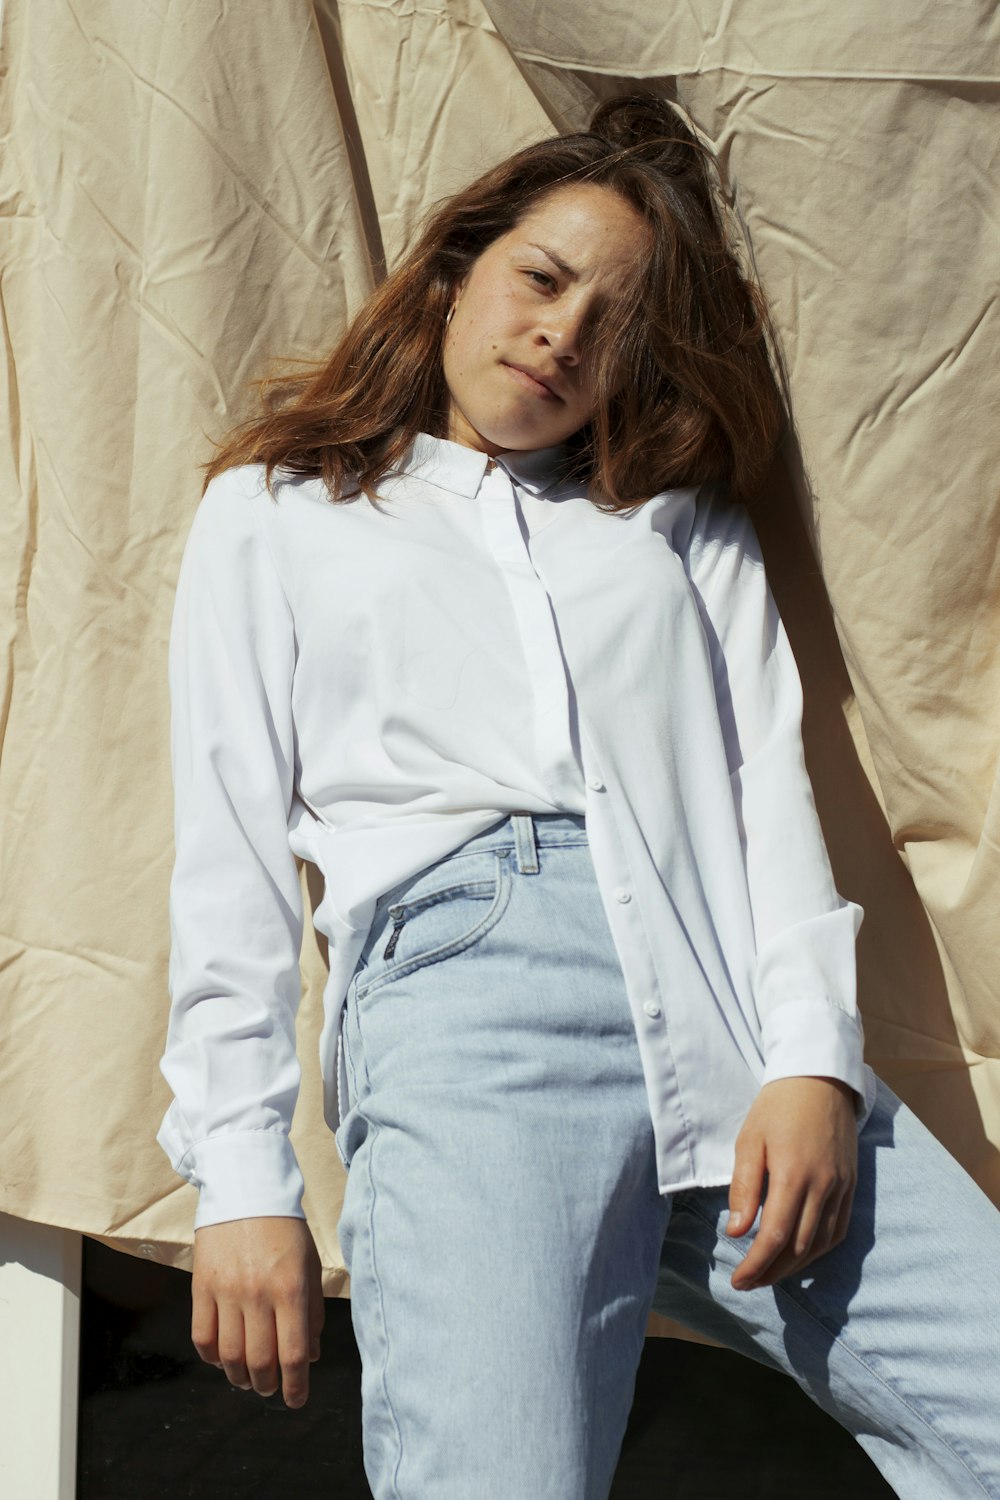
[0,0,1000,1314]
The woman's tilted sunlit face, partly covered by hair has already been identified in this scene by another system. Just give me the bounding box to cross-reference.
[444,183,649,455]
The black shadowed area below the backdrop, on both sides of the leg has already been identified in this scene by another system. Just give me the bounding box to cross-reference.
[76,1238,894,1500]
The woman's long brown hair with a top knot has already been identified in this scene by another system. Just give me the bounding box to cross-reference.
[204,93,783,510]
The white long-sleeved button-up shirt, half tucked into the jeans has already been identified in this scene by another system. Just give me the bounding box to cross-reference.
[157,434,876,1227]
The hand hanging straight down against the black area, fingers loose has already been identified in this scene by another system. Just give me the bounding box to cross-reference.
[190,1217,324,1407]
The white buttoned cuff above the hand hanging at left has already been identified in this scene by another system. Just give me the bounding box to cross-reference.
[183,1130,306,1229]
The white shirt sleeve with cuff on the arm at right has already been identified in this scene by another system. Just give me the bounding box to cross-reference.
[688,488,867,1118]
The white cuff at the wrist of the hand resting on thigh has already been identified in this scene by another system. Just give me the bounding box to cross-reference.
[762,999,871,1121]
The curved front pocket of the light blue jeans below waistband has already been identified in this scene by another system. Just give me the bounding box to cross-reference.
[355,849,513,1001]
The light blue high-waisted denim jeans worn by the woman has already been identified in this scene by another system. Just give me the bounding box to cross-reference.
[337,813,1000,1500]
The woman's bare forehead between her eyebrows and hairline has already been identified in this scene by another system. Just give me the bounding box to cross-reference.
[502,183,651,281]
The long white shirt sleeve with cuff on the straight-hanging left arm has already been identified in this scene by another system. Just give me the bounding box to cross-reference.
[156,470,304,1229]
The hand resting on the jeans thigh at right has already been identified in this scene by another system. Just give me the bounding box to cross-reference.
[726,1077,858,1292]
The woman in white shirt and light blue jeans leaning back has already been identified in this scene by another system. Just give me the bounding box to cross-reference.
[159,95,1000,1500]
